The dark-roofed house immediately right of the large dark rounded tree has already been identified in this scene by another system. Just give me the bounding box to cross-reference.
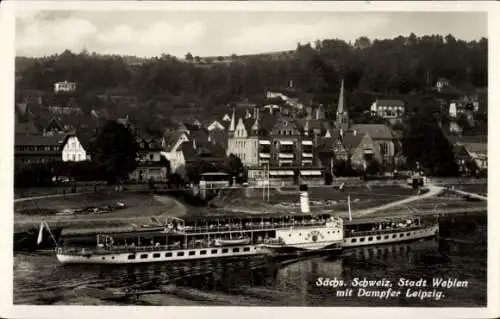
[129,134,169,183]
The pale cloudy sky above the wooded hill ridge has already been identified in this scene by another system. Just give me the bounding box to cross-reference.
[16,10,487,57]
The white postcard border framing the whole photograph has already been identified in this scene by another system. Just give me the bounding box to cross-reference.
[0,1,500,319]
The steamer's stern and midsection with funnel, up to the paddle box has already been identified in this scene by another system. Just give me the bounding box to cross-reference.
[56,186,344,264]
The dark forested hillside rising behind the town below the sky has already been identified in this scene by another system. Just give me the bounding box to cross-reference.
[16,34,488,130]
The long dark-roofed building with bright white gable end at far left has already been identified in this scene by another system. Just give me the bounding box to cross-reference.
[14,134,90,164]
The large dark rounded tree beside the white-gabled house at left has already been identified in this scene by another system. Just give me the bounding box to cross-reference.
[93,121,137,184]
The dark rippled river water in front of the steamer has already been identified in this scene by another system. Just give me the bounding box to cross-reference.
[14,214,487,307]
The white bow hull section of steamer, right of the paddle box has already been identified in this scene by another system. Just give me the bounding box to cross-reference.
[342,225,439,248]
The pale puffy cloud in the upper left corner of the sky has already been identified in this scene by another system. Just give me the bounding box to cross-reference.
[16,13,98,55]
